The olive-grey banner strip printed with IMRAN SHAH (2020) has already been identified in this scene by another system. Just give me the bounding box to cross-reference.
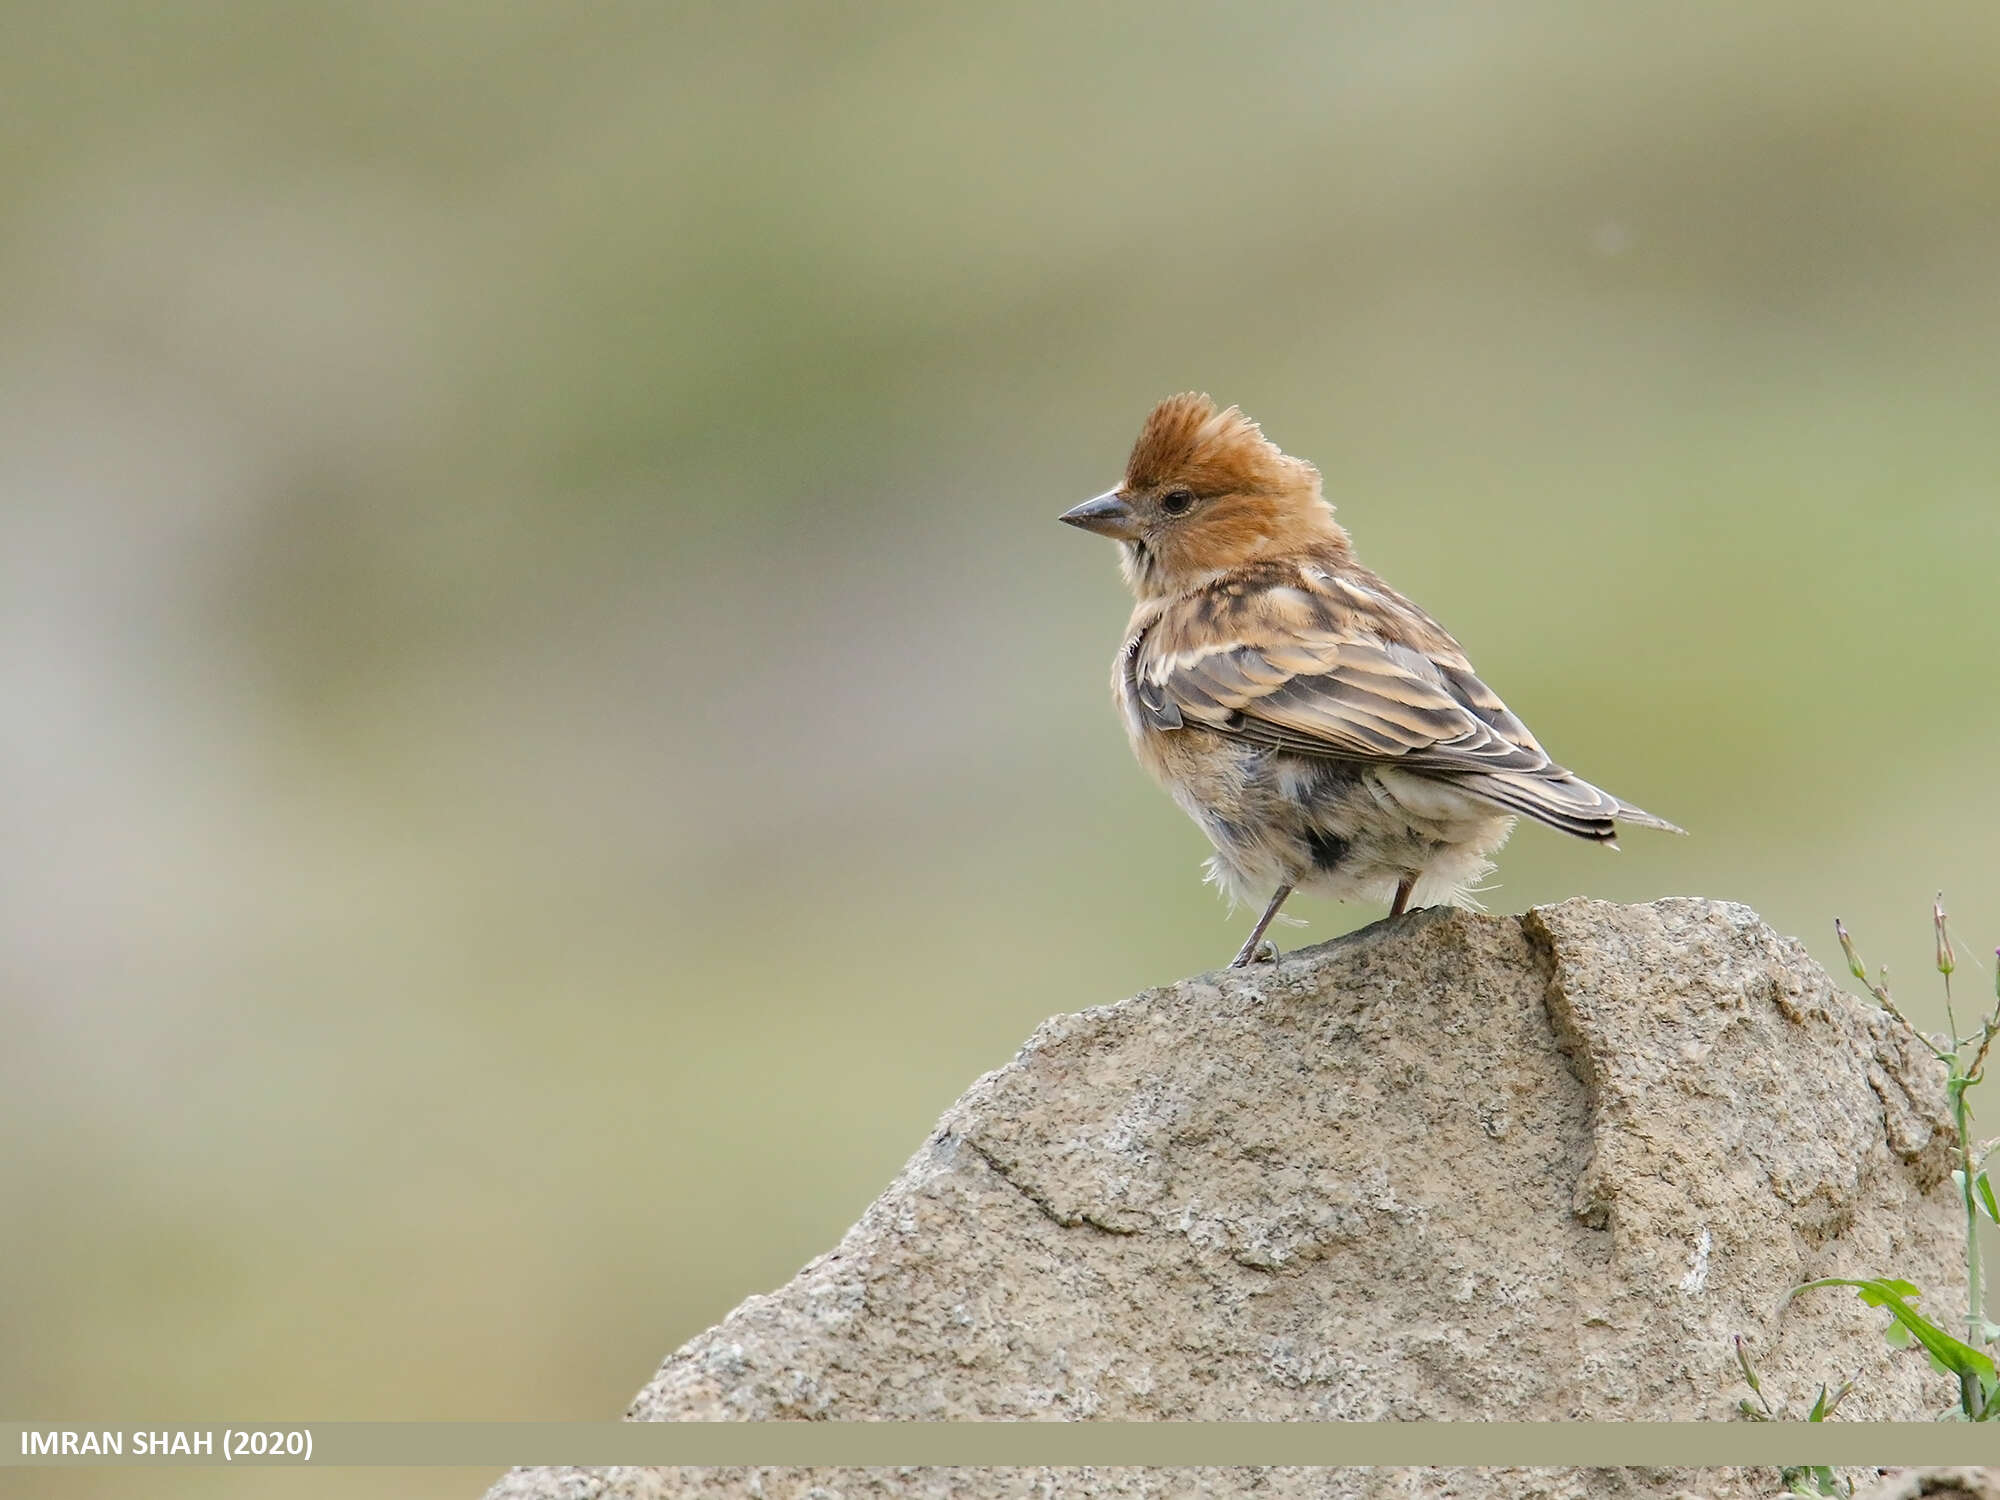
[0,1422,2000,1468]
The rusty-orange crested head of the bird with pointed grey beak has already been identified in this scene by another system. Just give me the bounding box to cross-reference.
[1062,392,1348,598]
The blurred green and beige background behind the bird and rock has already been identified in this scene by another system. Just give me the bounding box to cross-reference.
[0,0,2000,1496]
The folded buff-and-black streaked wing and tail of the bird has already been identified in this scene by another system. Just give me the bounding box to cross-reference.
[1132,596,1672,840]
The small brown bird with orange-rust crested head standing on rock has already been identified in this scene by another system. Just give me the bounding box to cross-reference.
[1060,392,1684,968]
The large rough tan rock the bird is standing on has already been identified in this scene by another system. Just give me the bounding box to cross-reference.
[494,900,1958,1500]
